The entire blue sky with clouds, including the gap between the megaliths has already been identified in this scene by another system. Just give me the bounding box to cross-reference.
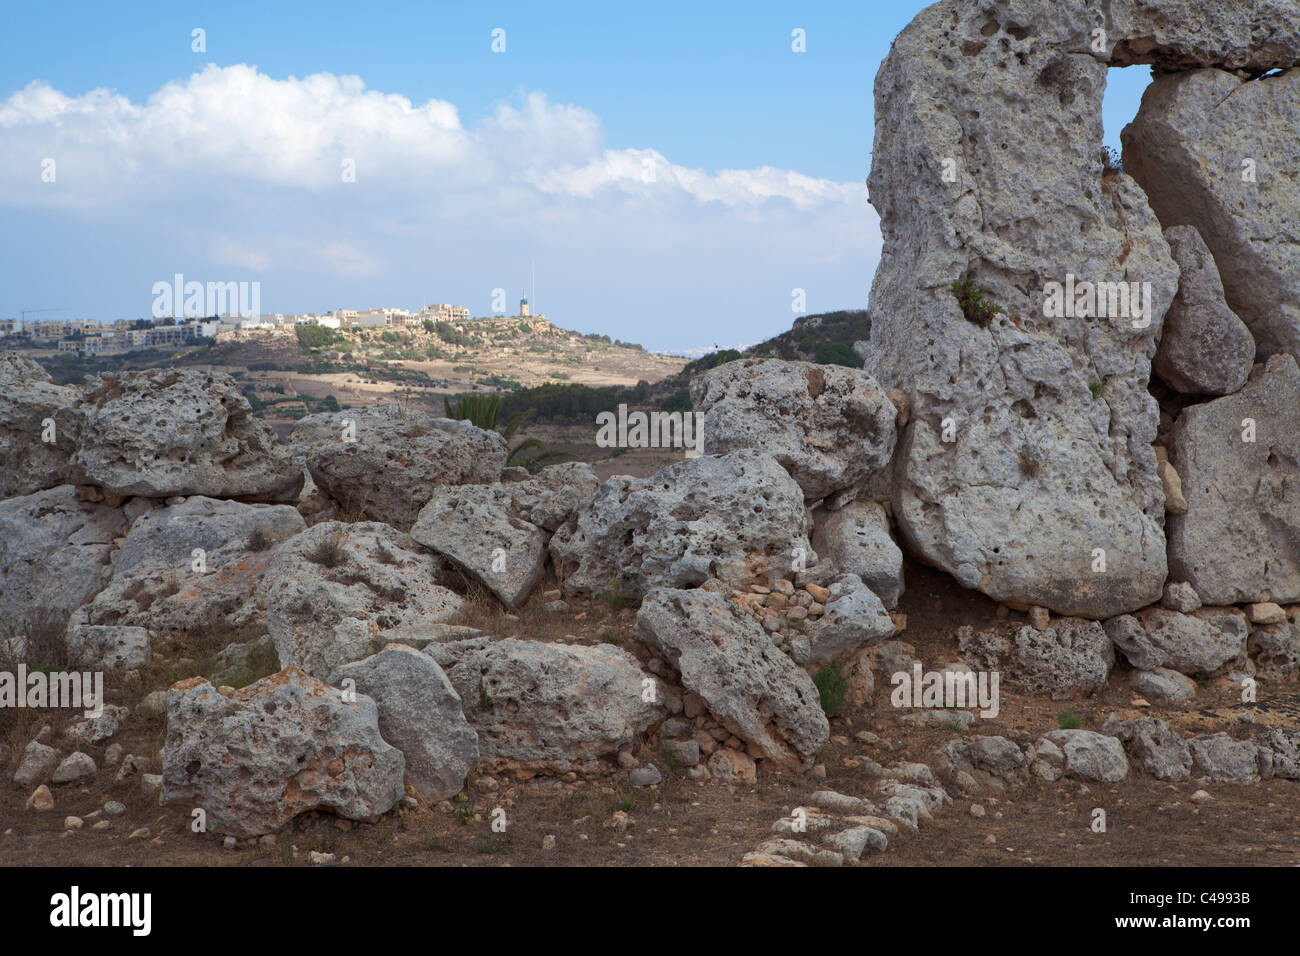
[0,0,1147,349]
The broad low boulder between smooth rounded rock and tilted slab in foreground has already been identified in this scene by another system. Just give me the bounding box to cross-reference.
[424,637,664,774]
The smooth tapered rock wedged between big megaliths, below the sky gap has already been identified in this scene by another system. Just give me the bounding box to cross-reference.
[1154,226,1253,395]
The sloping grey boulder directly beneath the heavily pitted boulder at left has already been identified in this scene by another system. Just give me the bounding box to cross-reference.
[69,496,307,632]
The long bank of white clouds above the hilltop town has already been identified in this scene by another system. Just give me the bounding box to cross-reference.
[0,64,880,341]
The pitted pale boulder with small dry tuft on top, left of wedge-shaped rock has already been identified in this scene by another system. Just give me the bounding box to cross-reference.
[257,522,462,676]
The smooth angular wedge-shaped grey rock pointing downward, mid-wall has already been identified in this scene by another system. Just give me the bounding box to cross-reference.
[411,485,546,607]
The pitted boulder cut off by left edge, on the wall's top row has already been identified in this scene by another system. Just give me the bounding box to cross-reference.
[0,351,79,498]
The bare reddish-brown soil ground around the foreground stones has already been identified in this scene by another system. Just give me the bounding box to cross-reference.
[0,566,1300,866]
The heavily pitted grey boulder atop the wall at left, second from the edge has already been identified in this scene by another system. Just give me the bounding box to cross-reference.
[55,369,303,502]
